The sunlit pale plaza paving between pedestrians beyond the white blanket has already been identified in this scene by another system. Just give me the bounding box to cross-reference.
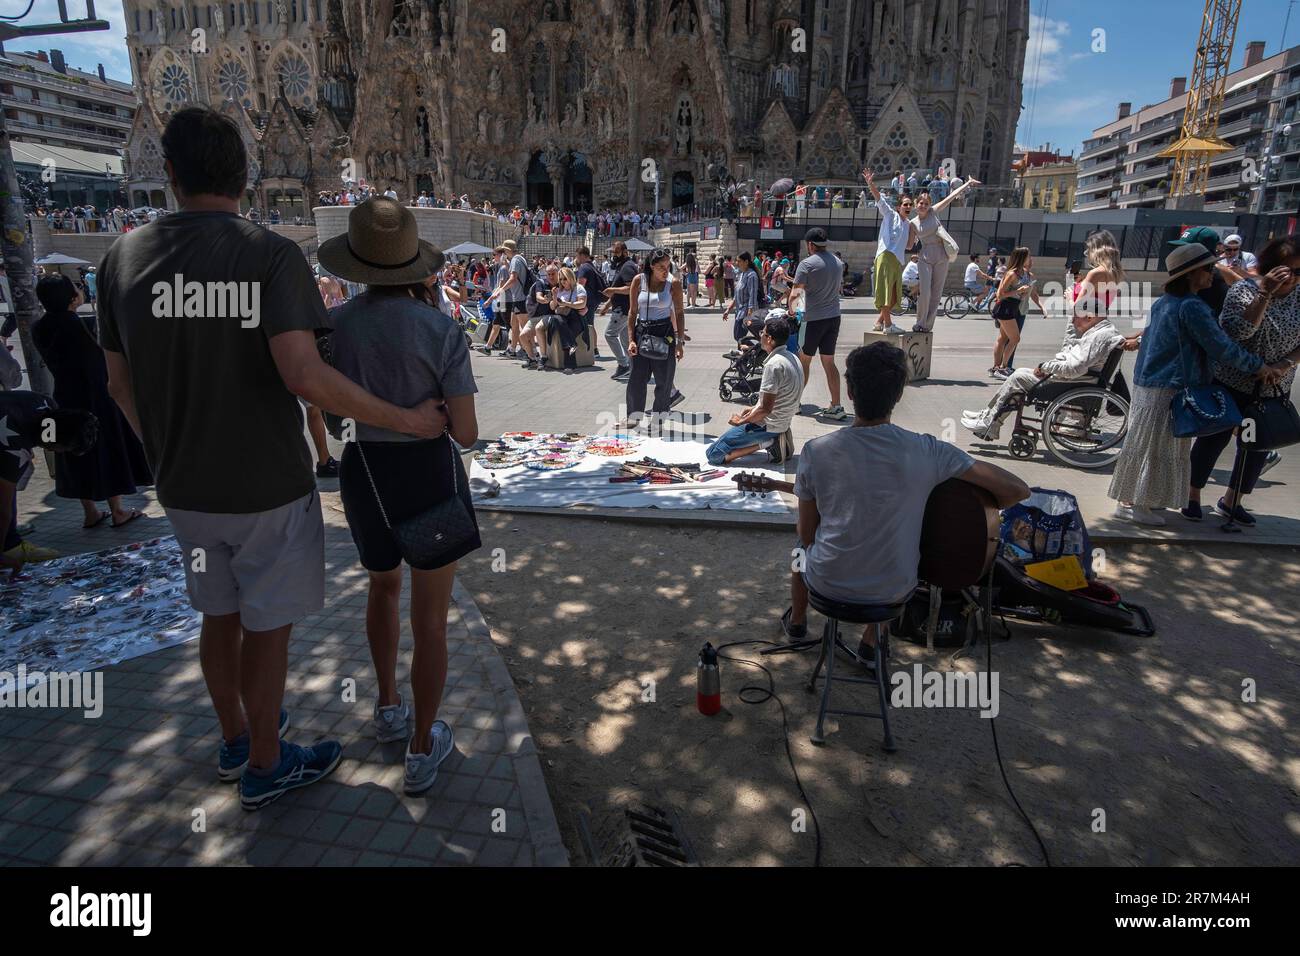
[475,298,1300,545]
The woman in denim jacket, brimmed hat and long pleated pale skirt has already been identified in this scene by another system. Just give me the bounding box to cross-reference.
[1108,243,1277,525]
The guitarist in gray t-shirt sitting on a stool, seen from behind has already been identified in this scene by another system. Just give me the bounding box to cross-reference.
[781,342,1030,666]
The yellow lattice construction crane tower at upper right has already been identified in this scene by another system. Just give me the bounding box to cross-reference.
[1160,0,1242,199]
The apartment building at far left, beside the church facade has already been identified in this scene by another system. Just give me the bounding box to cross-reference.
[0,49,137,157]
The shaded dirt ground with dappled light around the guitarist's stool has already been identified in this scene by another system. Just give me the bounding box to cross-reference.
[449,514,1300,865]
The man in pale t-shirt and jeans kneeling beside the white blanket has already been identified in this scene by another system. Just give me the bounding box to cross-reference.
[705,319,803,464]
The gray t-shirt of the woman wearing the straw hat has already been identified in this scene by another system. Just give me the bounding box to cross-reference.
[329,293,478,441]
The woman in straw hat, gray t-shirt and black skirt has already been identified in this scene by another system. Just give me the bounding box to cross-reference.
[317,198,481,793]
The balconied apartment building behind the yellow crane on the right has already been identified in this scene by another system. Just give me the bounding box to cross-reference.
[1074,40,1300,213]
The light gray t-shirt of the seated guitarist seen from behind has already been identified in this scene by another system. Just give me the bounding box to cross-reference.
[794,424,975,604]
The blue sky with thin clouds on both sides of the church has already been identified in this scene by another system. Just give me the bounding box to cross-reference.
[0,0,1300,153]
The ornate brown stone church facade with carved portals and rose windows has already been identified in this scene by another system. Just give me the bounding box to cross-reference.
[124,0,1028,216]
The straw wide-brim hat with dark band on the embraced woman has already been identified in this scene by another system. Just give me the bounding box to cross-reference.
[316,196,447,285]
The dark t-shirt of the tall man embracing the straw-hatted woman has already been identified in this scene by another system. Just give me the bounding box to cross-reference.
[99,206,325,514]
